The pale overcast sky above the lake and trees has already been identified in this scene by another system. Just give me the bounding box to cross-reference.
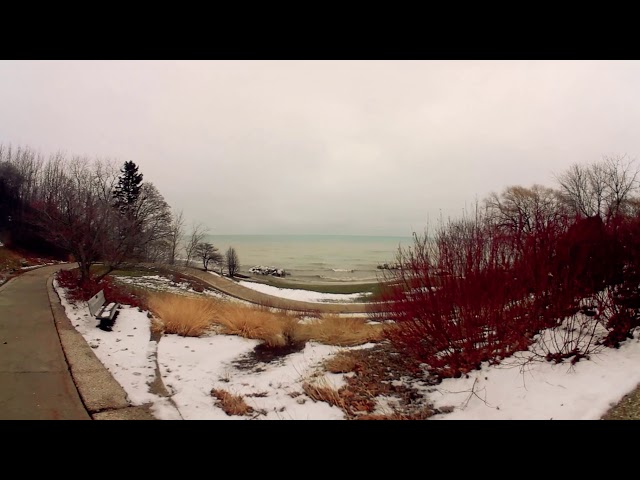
[0,60,640,236]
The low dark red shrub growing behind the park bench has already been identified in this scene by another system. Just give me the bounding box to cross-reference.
[56,269,148,310]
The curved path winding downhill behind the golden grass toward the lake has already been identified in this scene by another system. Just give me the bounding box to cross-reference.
[168,265,370,315]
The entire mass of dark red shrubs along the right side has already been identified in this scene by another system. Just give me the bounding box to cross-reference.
[371,206,640,377]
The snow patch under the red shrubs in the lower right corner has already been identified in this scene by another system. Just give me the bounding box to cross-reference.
[431,331,640,420]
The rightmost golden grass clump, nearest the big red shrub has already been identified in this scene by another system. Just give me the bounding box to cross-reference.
[299,315,384,347]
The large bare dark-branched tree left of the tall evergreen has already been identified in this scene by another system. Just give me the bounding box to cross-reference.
[10,149,178,279]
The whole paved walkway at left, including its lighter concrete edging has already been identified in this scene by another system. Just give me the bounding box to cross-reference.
[0,265,153,420]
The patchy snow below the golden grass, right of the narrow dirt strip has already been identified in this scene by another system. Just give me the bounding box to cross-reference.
[159,335,343,420]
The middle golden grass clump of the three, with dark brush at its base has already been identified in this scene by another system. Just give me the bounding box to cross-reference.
[215,303,305,347]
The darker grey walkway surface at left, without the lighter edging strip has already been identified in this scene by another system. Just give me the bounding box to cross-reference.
[0,265,91,420]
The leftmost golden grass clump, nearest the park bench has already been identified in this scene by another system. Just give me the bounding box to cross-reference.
[148,293,222,337]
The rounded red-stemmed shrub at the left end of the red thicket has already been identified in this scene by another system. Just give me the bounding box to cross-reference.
[372,217,538,377]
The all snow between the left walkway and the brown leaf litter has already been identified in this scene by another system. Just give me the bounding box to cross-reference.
[54,281,358,420]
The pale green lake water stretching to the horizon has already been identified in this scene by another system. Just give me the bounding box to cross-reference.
[205,235,412,282]
